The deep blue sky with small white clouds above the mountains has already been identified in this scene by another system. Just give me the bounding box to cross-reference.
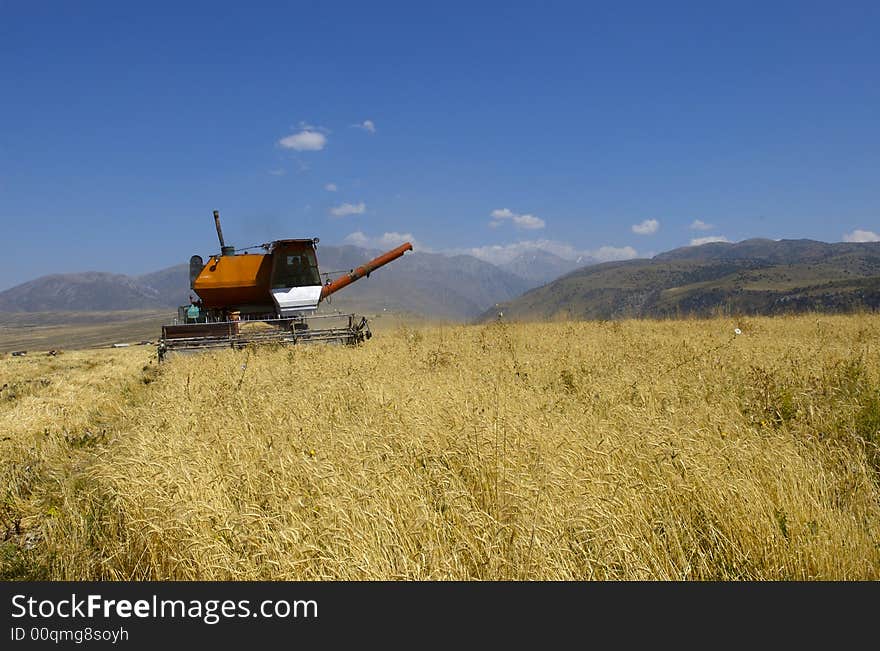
[0,0,880,289]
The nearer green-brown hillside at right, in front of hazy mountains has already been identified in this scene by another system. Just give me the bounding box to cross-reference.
[481,240,880,320]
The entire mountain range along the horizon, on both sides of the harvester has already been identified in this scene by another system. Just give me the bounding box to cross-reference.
[0,239,880,321]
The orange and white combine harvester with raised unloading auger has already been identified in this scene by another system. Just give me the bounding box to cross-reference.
[158,210,412,361]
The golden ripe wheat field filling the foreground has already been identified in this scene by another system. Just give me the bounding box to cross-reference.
[0,314,880,580]
